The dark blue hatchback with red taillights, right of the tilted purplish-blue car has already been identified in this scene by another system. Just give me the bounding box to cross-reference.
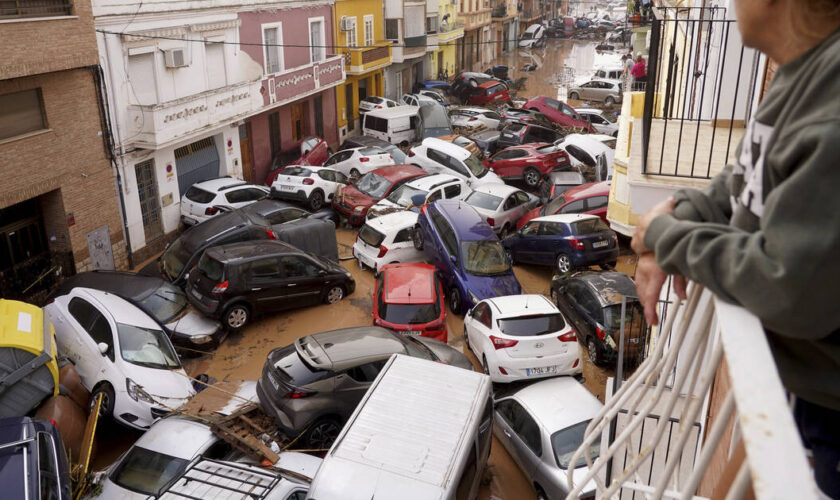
[502,214,618,274]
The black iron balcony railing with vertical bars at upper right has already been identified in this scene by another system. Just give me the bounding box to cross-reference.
[642,8,761,179]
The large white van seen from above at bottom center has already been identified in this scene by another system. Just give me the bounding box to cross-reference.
[306,354,493,500]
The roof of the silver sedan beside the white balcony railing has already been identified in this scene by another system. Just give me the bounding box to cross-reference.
[513,377,604,434]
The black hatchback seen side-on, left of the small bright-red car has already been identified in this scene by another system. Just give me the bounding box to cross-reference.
[186,241,356,330]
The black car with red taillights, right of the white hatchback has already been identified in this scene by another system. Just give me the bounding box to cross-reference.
[551,271,648,365]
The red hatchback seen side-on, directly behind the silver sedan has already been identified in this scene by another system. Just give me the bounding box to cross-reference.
[484,142,570,188]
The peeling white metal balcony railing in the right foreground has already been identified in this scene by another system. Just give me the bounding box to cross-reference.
[566,285,819,500]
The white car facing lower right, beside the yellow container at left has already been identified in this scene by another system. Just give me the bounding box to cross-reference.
[45,287,195,430]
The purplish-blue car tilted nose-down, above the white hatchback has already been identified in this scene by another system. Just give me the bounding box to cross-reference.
[413,200,522,314]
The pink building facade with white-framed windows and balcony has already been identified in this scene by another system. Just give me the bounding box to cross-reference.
[239,2,345,183]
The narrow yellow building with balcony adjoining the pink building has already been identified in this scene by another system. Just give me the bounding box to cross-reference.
[333,0,392,141]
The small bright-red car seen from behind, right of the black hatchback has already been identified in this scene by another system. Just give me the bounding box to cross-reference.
[373,264,447,343]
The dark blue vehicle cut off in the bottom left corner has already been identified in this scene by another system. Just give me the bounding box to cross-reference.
[0,417,71,500]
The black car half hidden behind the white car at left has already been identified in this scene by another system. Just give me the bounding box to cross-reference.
[48,271,225,350]
